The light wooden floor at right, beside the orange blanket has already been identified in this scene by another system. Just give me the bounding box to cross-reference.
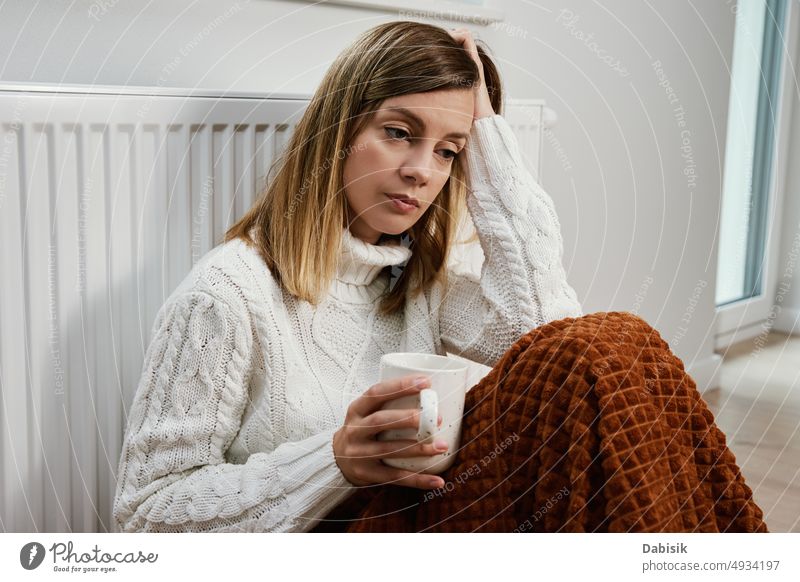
[703,332,800,532]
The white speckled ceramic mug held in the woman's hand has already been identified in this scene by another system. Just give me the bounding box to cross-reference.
[377,352,469,475]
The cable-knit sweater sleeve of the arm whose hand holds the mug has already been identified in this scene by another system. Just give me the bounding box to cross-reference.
[113,290,354,532]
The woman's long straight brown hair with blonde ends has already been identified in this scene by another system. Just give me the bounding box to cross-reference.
[224,21,502,314]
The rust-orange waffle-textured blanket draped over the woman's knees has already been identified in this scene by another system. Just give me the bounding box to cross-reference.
[312,312,767,532]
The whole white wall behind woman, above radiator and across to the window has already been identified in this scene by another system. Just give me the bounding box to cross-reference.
[0,0,744,388]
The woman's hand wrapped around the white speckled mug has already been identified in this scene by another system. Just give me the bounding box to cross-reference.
[333,375,447,489]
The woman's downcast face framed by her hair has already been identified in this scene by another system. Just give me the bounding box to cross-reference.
[344,89,474,244]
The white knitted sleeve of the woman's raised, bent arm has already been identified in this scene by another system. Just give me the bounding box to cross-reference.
[436,115,582,366]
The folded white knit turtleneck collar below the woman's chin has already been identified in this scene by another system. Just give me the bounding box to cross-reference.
[331,228,412,303]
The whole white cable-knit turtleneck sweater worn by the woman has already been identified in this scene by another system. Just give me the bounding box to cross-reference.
[114,115,582,532]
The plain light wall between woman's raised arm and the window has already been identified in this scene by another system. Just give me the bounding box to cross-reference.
[484,1,735,392]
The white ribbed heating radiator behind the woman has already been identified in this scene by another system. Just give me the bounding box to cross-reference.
[0,84,543,532]
